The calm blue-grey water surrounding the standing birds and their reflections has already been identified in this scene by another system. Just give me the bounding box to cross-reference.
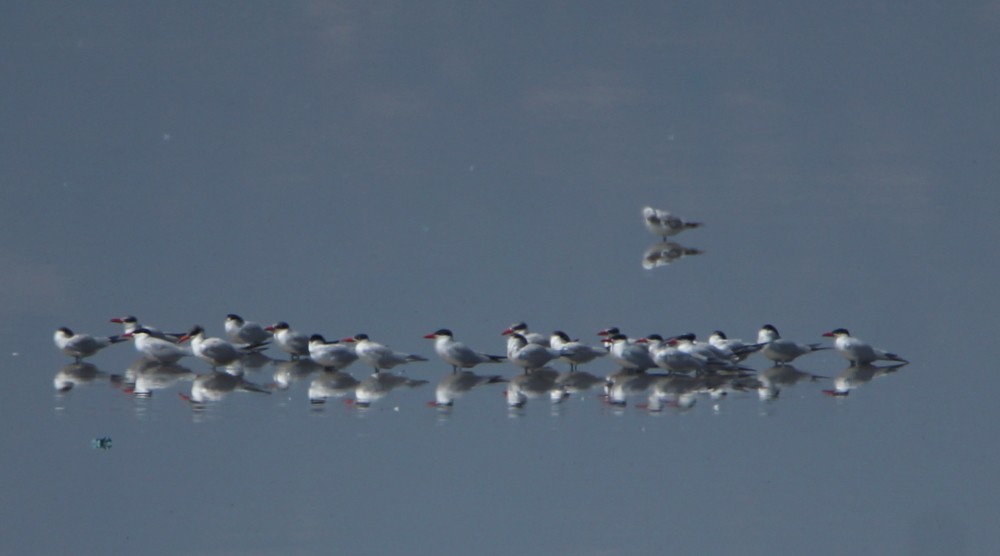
[0,1,1000,555]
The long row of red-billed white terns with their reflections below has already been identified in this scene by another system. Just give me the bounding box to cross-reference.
[54,314,907,407]
